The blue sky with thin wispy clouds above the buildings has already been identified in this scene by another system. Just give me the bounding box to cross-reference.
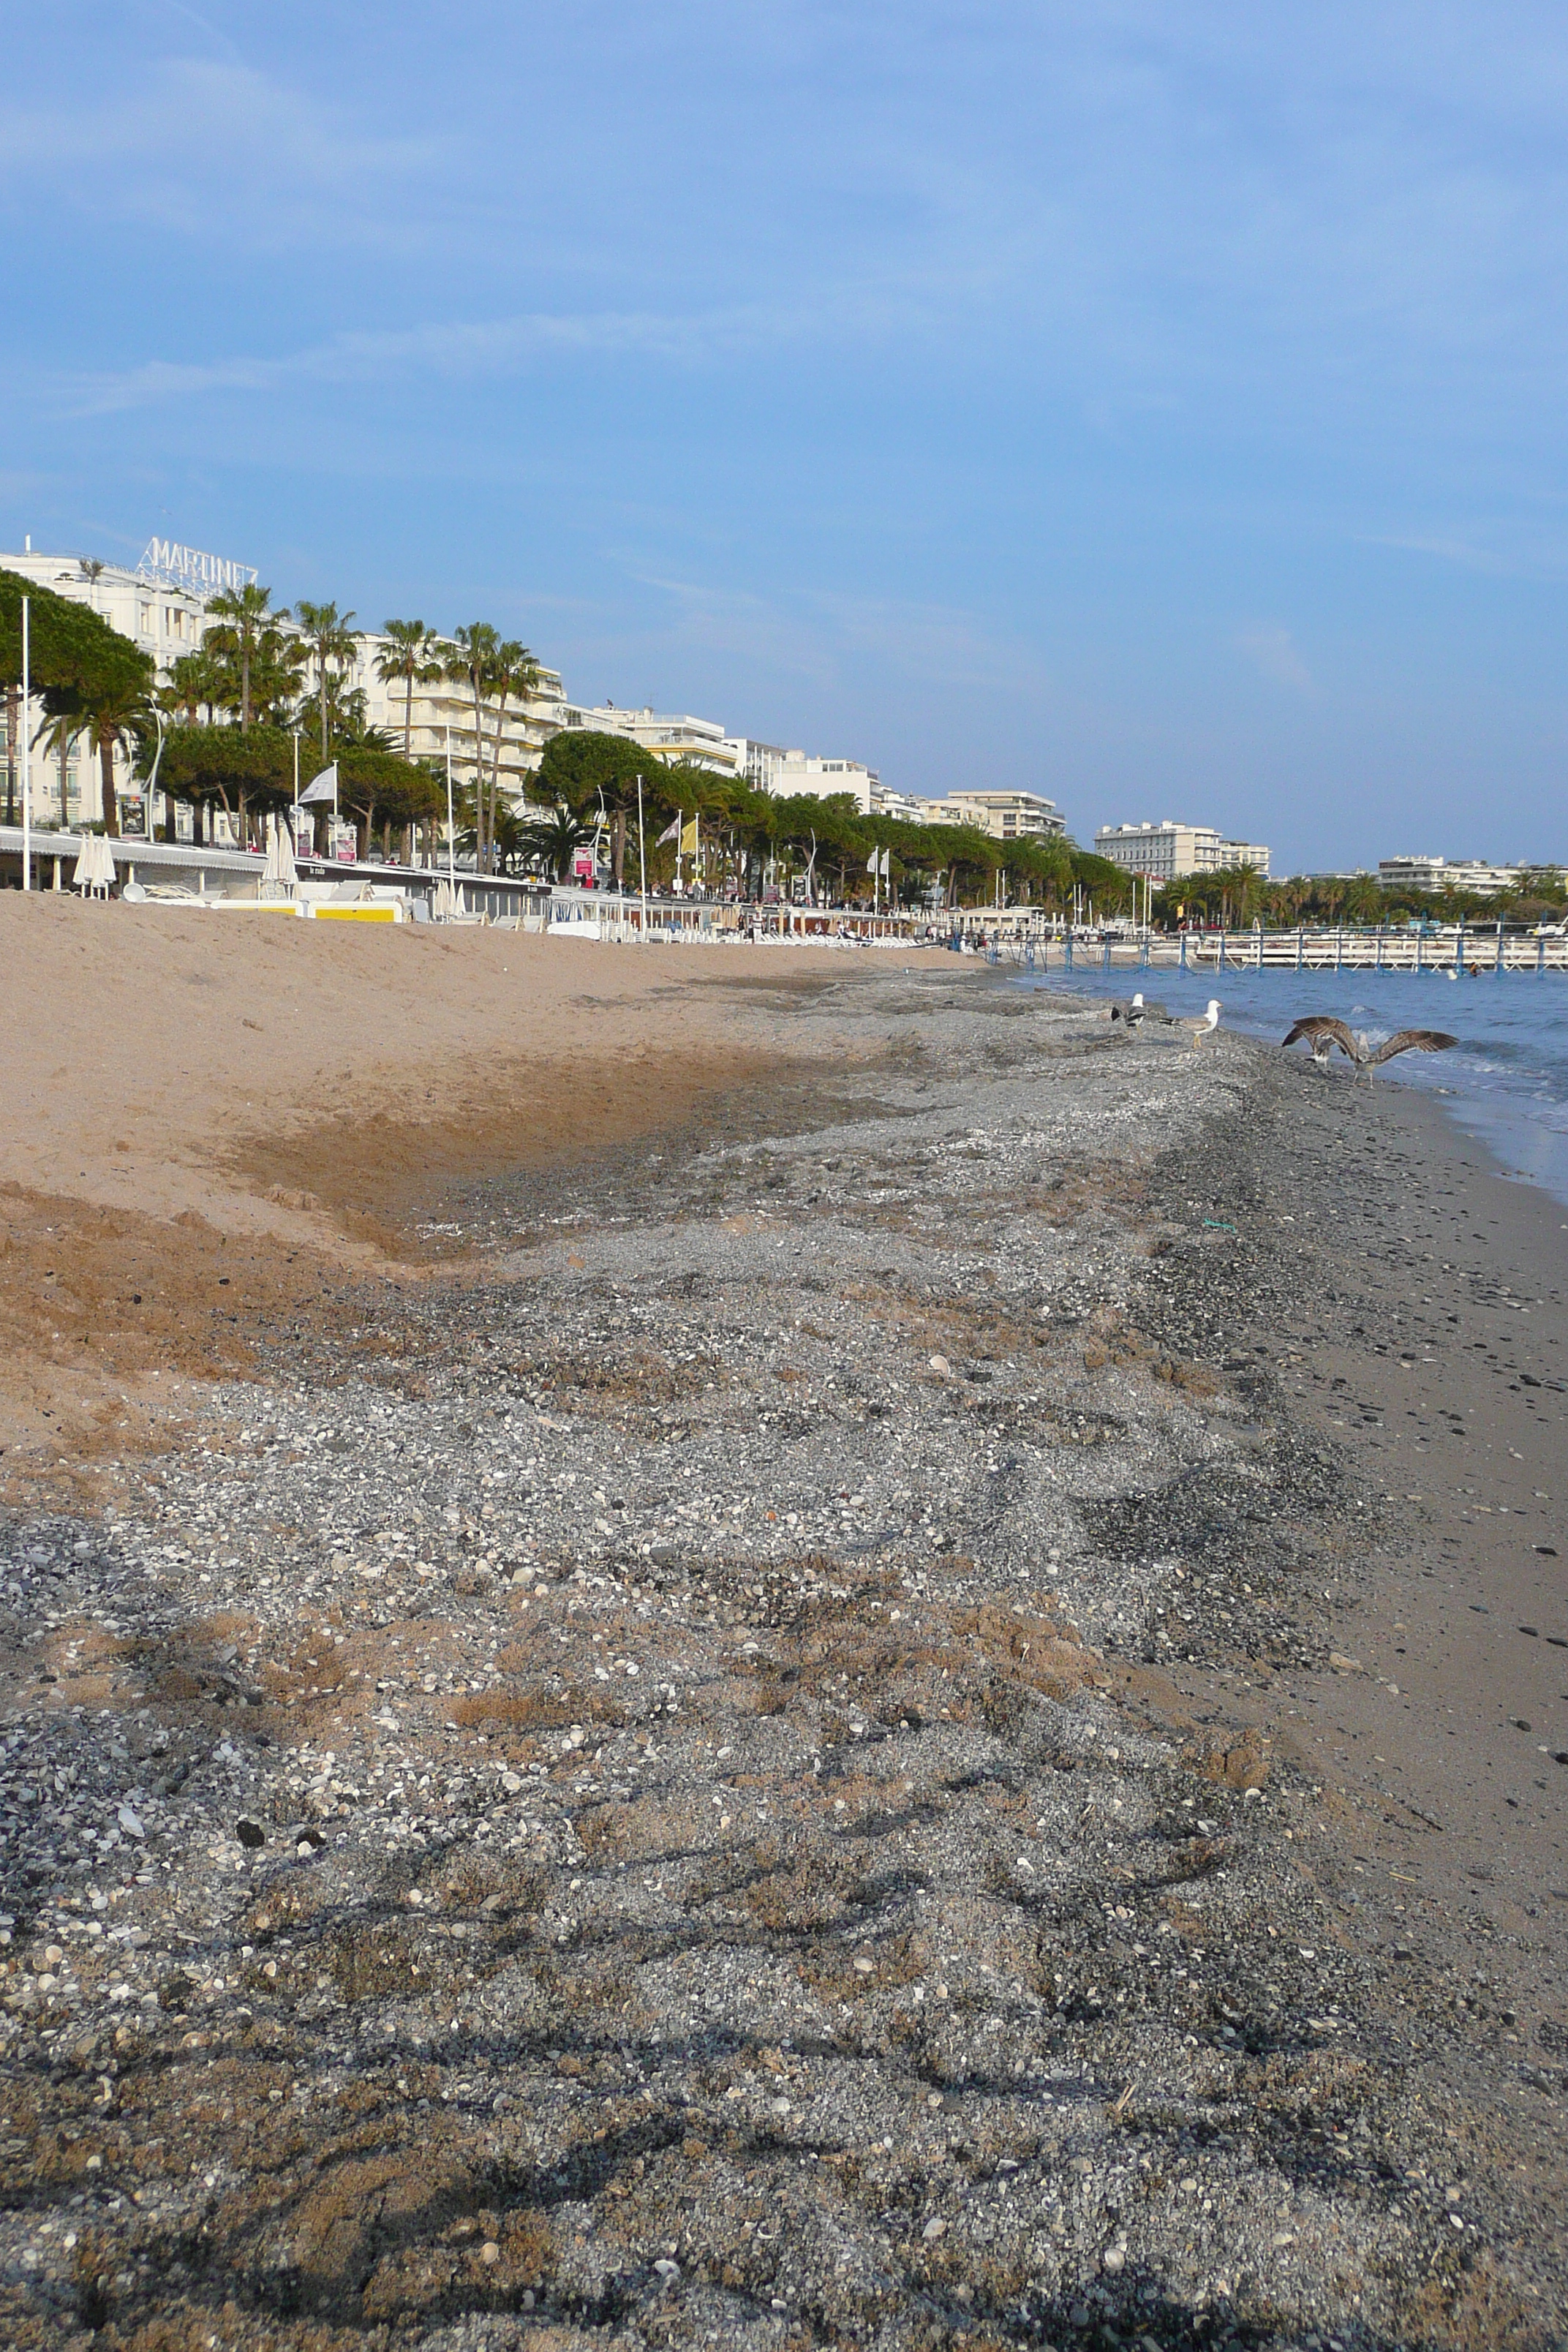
[0,0,1568,872]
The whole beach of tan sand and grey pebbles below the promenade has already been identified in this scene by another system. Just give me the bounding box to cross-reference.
[0,899,1568,2352]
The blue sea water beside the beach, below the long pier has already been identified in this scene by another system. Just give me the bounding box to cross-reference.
[1025,950,1568,1202]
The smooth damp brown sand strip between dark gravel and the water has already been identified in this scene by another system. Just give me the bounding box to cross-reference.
[1152,1079,1568,2060]
